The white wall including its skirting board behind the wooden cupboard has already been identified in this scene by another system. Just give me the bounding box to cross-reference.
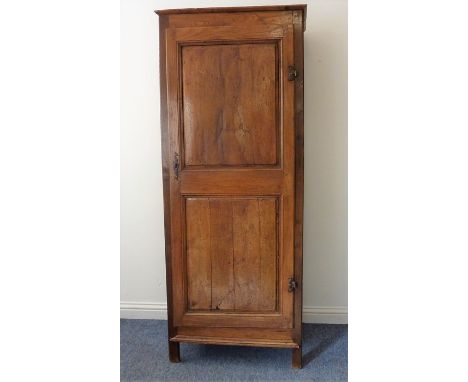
[121,0,348,323]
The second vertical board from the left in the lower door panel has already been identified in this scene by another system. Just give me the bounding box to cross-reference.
[210,199,235,310]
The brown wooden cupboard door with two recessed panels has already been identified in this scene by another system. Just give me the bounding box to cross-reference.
[165,24,295,328]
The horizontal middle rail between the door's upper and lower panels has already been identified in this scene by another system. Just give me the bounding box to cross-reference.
[179,169,287,195]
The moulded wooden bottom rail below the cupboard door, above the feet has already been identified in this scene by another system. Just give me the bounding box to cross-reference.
[175,326,293,341]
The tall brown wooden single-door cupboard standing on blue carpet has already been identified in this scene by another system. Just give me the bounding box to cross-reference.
[156,5,306,367]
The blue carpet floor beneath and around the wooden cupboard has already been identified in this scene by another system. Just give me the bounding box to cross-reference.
[120,320,348,382]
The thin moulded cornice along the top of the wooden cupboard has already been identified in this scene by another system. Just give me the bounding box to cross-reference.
[154,4,307,30]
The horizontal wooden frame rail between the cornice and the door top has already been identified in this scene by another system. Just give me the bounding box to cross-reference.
[169,11,292,28]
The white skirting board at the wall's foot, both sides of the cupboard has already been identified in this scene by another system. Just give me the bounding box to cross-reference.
[120,301,348,324]
